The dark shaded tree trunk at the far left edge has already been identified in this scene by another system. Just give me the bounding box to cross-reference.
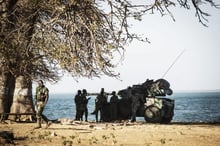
[0,73,15,120]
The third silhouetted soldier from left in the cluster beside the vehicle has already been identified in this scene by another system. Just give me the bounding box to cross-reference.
[94,88,108,122]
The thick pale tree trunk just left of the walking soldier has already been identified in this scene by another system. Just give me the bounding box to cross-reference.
[9,76,35,121]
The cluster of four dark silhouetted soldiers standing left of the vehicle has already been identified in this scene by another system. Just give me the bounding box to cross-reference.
[74,88,118,122]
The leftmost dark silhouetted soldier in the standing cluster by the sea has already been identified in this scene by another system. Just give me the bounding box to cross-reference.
[74,90,82,121]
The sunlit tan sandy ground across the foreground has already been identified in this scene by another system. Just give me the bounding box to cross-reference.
[0,122,220,146]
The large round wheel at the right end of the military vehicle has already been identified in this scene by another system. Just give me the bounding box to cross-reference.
[144,105,162,123]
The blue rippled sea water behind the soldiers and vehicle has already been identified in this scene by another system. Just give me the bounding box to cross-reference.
[44,92,220,123]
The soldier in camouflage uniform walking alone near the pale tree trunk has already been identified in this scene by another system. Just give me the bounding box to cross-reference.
[35,80,51,129]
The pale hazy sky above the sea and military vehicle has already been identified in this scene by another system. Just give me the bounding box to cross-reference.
[34,4,220,93]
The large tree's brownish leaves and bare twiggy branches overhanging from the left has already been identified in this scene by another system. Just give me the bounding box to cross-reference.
[0,0,218,120]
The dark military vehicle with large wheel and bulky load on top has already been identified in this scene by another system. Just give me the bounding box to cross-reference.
[99,79,174,123]
